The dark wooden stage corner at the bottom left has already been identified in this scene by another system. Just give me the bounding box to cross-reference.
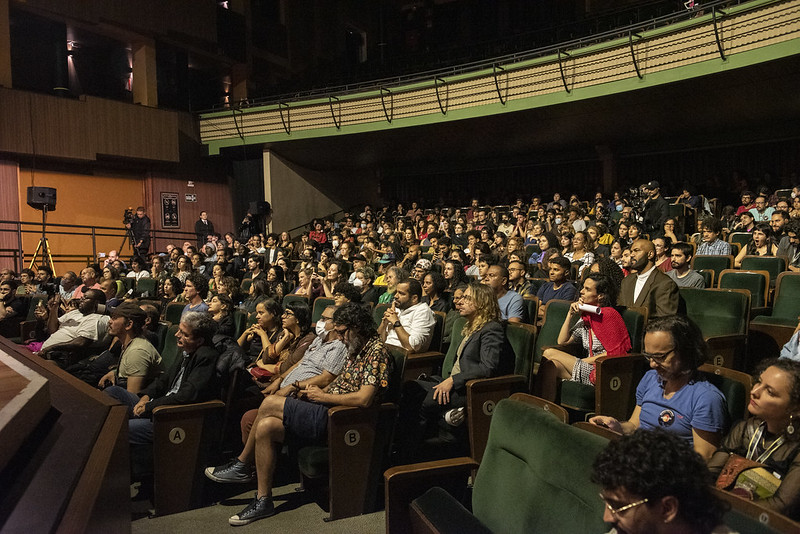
[0,337,131,534]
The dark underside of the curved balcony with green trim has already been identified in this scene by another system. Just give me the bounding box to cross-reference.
[251,54,800,171]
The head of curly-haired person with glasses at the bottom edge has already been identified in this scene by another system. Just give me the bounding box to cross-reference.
[591,429,734,534]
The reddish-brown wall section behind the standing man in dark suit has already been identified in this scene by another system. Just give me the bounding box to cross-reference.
[145,174,238,251]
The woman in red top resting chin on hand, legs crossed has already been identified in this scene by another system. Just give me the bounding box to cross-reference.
[542,273,631,385]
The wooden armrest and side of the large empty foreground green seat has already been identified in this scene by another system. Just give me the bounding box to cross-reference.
[383,457,478,534]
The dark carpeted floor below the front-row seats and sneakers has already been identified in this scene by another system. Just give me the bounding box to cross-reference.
[131,483,385,534]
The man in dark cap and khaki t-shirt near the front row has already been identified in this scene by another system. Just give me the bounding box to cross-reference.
[97,301,162,394]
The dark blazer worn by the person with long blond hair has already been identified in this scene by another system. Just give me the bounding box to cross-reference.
[452,321,514,389]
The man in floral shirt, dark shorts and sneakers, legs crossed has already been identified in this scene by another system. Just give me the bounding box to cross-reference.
[206,303,392,526]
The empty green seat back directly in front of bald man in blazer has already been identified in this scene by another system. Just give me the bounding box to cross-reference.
[679,287,750,338]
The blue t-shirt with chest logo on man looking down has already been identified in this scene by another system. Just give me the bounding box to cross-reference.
[636,369,728,440]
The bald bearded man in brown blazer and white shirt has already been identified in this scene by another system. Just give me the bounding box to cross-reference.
[618,239,678,319]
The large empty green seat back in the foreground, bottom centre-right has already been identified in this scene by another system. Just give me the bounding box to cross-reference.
[472,399,608,534]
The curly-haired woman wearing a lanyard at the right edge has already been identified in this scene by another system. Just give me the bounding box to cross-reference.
[708,358,800,520]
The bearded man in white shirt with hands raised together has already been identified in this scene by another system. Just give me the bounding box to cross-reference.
[378,278,436,352]
